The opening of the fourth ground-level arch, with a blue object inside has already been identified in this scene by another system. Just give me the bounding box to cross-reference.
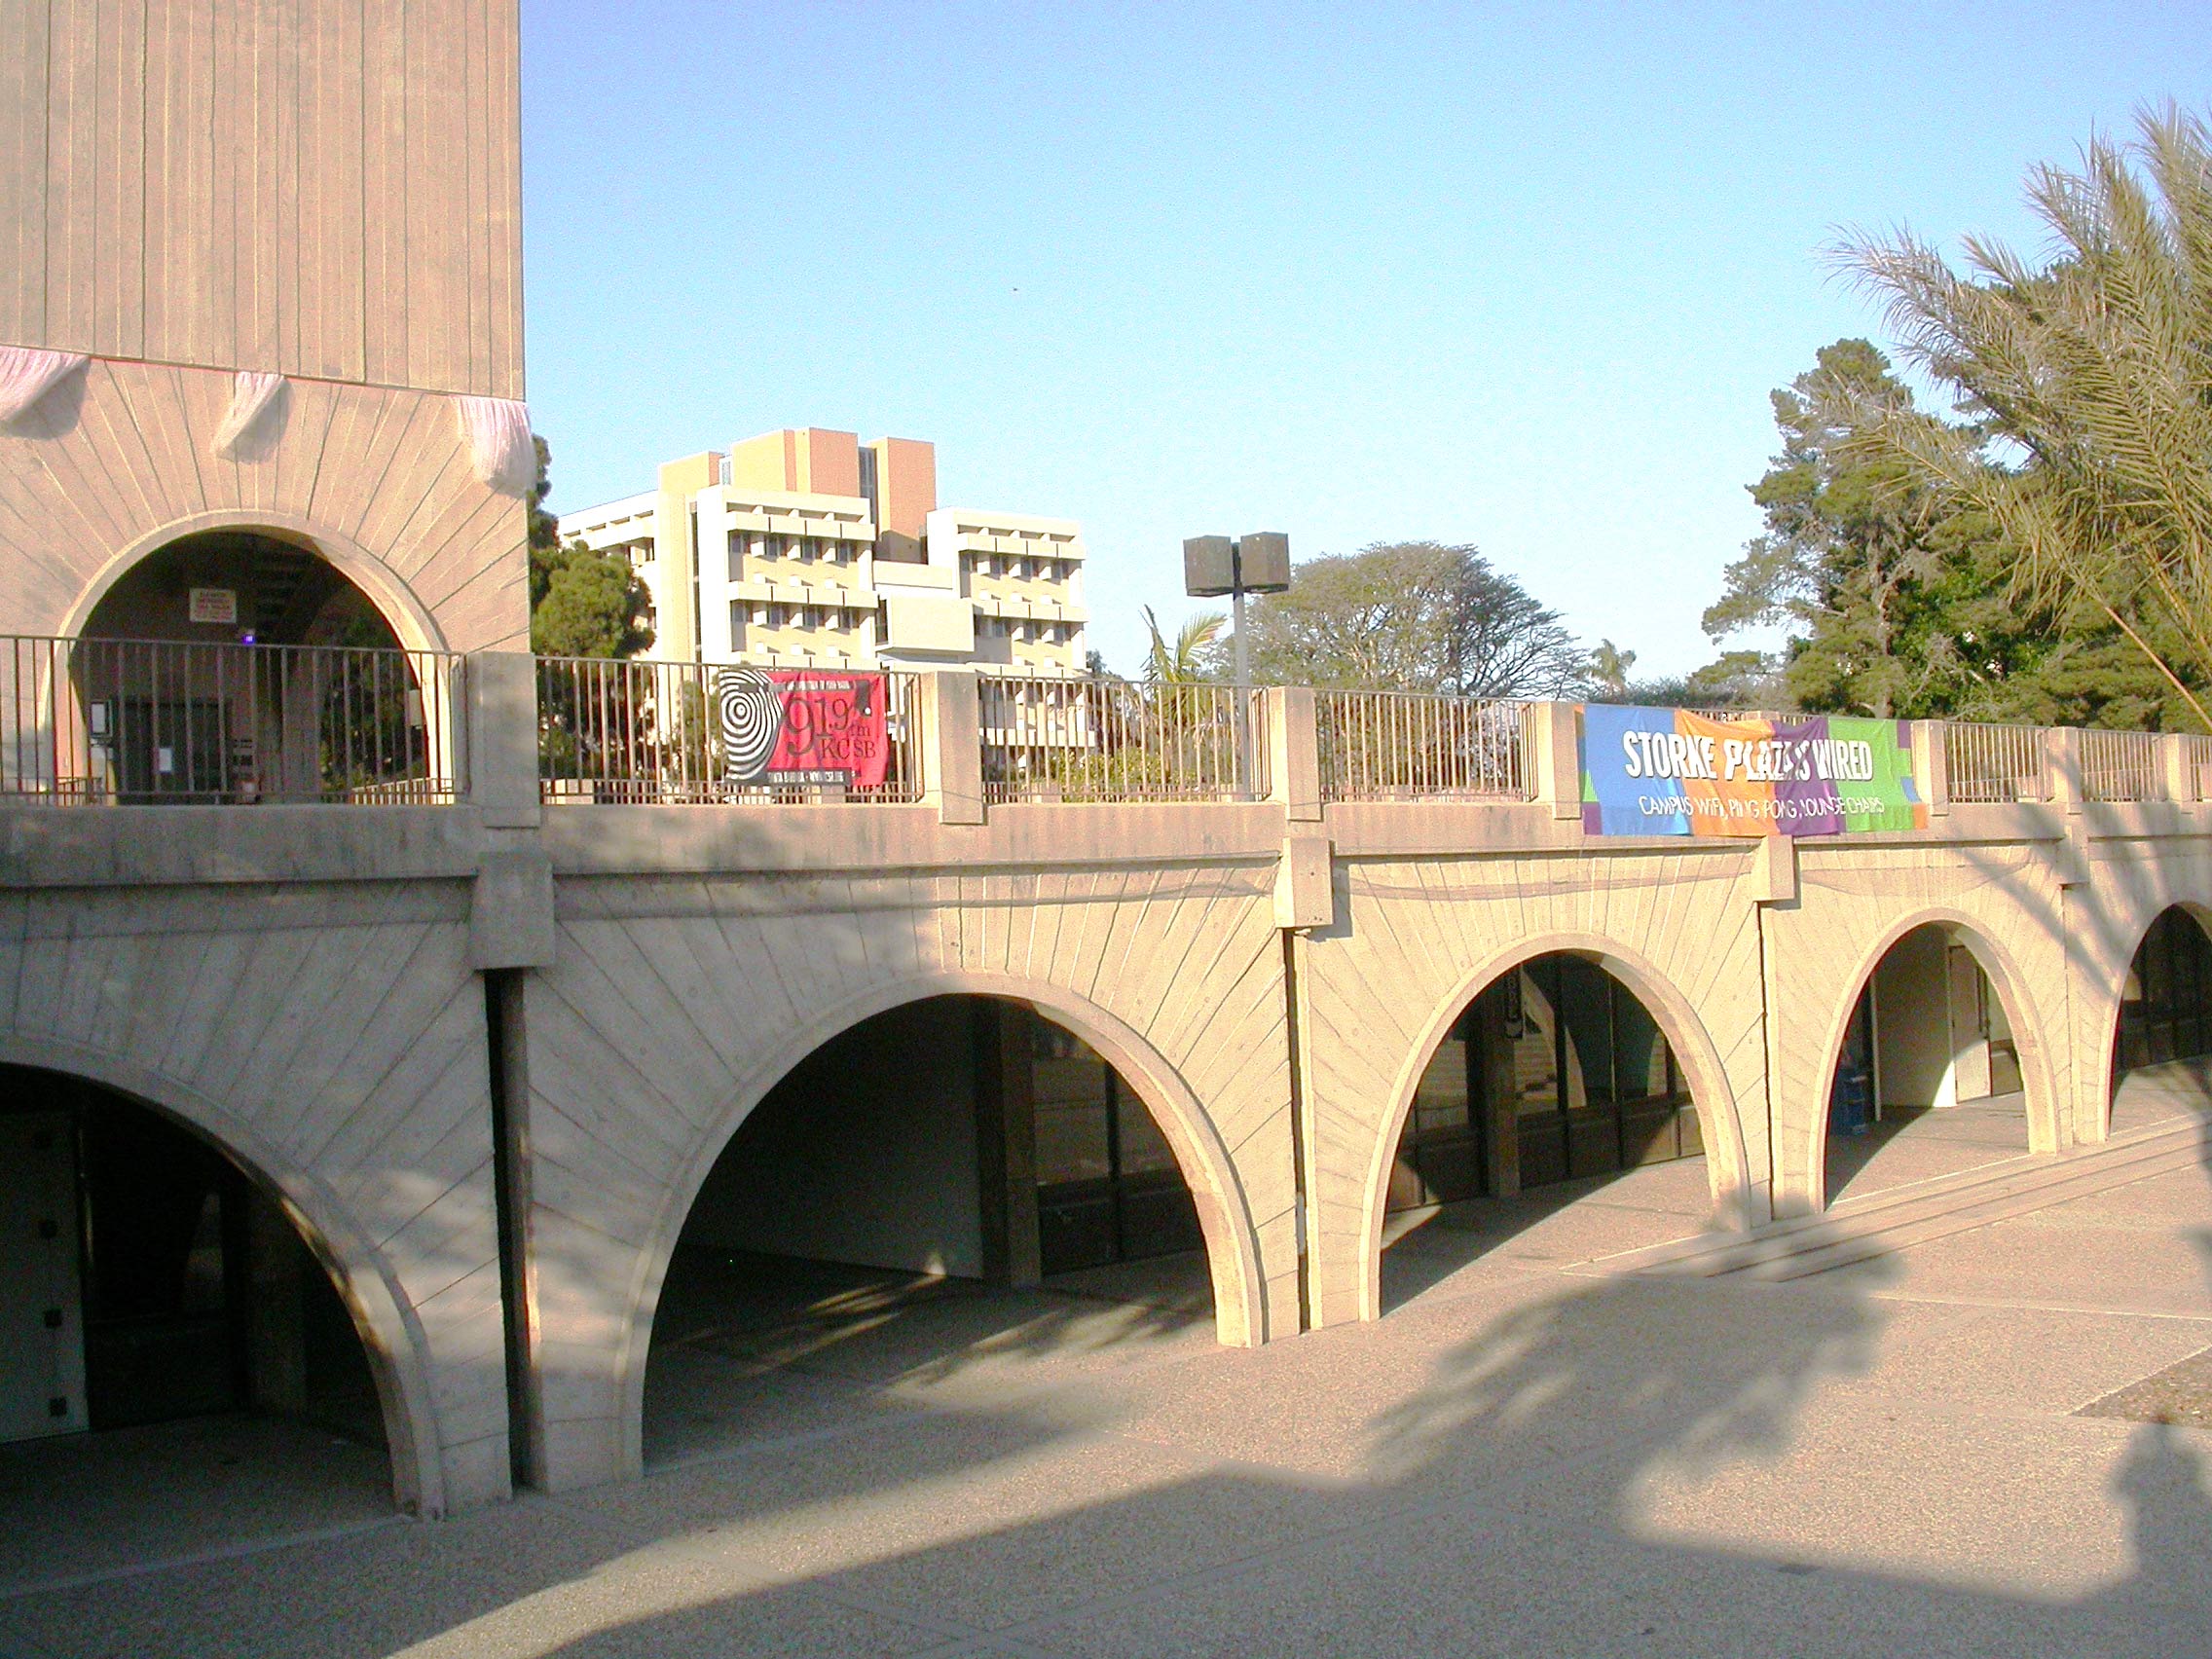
[1821,920,2031,1201]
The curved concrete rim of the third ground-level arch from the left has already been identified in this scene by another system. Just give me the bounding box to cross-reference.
[1358,929,1756,1318]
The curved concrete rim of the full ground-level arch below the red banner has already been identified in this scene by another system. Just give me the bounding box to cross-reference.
[617,969,1268,1475]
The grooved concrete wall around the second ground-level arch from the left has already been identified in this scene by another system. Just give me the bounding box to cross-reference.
[529,865,1299,1487]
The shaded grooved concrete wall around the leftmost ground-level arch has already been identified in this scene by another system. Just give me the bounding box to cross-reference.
[0,883,506,1513]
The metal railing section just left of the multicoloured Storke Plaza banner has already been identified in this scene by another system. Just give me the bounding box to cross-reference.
[1314,690,1529,800]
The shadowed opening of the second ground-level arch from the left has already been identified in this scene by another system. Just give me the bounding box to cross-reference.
[642,993,1214,1464]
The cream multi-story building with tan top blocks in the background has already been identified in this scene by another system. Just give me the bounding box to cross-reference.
[560,426,1088,680]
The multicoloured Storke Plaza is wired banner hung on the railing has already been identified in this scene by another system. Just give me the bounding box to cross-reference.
[1581,703,1929,836]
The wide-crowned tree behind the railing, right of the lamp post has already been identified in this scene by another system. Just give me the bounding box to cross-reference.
[1214,542,1588,697]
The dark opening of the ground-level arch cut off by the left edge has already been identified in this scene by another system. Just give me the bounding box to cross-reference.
[0,1066,396,1577]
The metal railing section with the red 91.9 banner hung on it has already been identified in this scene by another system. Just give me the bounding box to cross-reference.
[537,657,922,805]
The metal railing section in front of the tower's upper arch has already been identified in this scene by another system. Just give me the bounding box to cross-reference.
[0,635,466,805]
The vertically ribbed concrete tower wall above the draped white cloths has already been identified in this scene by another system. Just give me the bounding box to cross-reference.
[0,0,522,398]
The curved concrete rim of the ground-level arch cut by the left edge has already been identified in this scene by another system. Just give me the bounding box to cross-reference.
[0,1031,445,1515]
